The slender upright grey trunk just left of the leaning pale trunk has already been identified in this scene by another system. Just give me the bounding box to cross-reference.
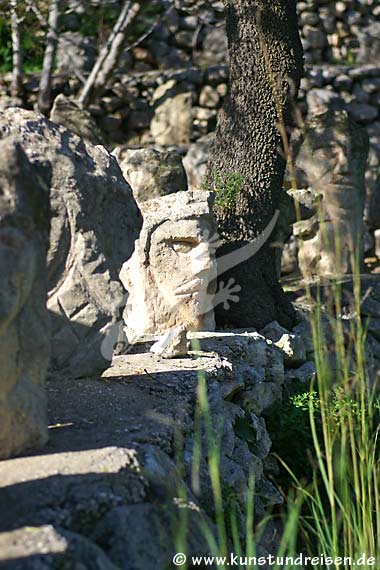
[37,0,60,115]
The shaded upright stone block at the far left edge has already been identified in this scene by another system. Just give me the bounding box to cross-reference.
[0,140,50,459]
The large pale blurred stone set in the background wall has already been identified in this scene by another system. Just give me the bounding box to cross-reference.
[150,93,192,146]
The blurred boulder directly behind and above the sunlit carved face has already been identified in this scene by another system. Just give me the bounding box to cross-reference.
[113,148,187,202]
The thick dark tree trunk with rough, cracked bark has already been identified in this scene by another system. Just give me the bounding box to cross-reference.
[206,0,303,328]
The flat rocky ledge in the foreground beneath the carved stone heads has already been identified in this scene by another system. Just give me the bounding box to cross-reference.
[0,333,290,570]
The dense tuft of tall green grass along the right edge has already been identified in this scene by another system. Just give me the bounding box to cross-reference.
[276,222,380,568]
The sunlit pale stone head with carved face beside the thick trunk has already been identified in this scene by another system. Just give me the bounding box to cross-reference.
[120,191,216,342]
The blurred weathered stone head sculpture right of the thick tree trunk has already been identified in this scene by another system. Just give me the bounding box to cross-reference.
[293,111,368,277]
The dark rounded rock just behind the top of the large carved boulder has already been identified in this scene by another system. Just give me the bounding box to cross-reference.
[50,93,102,144]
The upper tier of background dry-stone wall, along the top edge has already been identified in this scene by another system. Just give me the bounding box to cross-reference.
[61,0,380,71]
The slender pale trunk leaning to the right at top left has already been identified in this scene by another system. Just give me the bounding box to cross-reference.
[78,0,142,107]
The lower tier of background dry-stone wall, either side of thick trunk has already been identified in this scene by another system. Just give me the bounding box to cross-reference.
[93,64,380,235]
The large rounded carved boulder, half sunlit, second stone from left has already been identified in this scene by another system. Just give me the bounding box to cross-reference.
[0,108,140,376]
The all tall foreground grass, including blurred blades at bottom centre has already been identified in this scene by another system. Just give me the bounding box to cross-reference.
[173,243,380,570]
